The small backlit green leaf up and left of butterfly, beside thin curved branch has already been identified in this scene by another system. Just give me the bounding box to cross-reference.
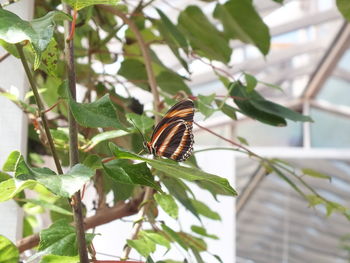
[118,59,150,91]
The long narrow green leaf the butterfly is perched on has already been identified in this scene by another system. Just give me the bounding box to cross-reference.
[109,143,237,195]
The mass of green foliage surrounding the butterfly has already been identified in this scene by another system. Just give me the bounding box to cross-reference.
[0,0,350,263]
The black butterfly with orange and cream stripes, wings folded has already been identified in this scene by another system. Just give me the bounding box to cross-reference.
[145,99,194,162]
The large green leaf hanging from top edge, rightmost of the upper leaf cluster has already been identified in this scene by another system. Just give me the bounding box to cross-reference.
[214,0,270,55]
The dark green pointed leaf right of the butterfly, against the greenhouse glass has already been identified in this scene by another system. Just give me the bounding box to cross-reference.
[230,82,312,126]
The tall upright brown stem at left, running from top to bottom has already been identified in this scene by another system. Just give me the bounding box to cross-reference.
[63,4,89,263]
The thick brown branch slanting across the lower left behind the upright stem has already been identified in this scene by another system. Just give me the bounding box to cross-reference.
[16,198,142,252]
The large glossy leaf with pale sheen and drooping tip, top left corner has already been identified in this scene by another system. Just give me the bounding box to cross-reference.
[0,9,70,69]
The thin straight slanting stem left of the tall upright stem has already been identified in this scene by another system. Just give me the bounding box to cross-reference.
[16,44,63,174]
